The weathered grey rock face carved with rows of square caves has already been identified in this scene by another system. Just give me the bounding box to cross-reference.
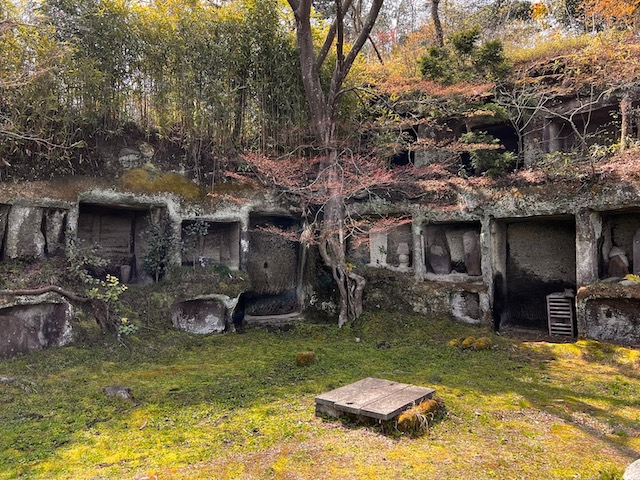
[0,162,640,348]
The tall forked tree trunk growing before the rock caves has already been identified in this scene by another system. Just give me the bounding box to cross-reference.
[288,0,383,326]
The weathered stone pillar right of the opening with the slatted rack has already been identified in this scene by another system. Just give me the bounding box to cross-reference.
[576,209,602,286]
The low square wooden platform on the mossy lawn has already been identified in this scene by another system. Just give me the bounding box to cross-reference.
[316,377,436,420]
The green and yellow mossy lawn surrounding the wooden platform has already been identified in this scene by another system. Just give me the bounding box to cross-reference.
[0,313,640,479]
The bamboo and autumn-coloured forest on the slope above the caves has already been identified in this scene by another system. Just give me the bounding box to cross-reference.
[0,0,638,181]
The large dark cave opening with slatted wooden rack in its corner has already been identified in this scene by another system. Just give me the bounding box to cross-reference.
[493,216,576,330]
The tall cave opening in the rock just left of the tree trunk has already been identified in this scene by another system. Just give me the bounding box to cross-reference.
[243,214,302,320]
